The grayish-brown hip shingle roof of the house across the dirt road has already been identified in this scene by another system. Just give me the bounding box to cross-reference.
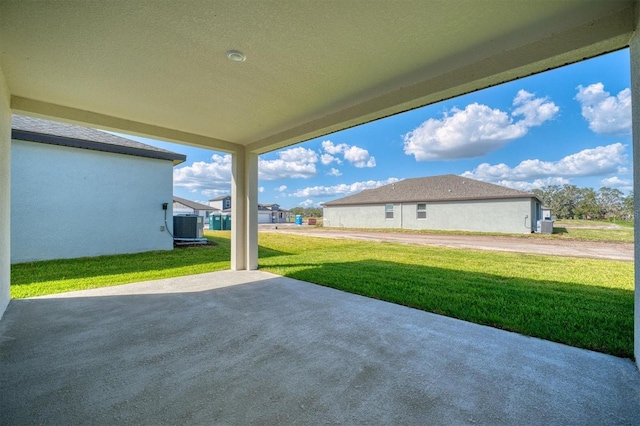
[324,175,537,207]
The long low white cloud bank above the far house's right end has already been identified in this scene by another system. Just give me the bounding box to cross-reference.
[462,143,627,182]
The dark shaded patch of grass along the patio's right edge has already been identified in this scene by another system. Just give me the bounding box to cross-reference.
[265,260,634,358]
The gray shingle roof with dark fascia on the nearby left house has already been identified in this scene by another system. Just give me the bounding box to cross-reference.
[11,115,187,166]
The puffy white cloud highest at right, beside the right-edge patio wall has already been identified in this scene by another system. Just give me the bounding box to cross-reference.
[576,83,631,134]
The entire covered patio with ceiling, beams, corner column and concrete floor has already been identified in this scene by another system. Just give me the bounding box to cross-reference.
[0,0,640,424]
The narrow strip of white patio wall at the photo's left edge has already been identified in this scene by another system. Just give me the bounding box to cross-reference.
[0,69,11,318]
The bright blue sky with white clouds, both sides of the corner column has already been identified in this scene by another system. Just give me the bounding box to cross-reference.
[124,49,632,208]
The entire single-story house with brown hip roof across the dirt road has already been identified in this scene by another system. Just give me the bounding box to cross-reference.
[323,175,542,233]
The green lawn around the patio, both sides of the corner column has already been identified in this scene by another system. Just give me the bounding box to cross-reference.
[11,231,634,357]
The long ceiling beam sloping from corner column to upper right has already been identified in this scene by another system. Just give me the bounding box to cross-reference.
[248,6,636,154]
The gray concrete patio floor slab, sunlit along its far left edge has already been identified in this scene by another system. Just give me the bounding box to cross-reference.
[0,271,640,425]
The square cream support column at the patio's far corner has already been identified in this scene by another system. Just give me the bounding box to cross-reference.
[231,148,258,271]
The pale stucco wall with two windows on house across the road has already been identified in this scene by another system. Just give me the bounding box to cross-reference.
[324,198,535,233]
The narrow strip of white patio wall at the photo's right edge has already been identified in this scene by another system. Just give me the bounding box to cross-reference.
[629,23,640,367]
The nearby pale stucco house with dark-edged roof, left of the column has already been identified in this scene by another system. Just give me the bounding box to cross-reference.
[11,115,186,263]
